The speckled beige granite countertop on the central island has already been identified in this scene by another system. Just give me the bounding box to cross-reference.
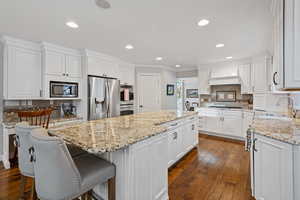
[49,110,197,154]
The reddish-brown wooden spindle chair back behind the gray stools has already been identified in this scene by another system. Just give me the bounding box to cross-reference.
[18,108,53,129]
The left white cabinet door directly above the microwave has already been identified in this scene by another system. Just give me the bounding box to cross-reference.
[45,51,66,76]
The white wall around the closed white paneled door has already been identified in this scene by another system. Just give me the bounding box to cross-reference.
[135,65,177,111]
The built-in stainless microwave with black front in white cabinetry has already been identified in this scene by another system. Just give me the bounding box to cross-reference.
[50,81,78,98]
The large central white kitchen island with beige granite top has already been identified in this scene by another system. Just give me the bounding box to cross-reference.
[49,110,198,200]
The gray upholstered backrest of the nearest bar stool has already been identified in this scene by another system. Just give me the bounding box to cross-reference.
[31,129,81,200]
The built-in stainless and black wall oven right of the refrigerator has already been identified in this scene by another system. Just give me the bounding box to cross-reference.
[120,85,134,115]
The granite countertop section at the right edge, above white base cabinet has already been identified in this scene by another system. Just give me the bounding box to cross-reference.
[252,117,300,145]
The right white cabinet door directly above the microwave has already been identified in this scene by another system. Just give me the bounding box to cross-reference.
[66,55,81,78]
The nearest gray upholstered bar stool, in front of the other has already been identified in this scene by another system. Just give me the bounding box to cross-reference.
[31,129,116,200]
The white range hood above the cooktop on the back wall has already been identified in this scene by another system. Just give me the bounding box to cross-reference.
[208,65,241,85]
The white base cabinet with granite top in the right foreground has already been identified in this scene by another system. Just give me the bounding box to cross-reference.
[249,114,300,200]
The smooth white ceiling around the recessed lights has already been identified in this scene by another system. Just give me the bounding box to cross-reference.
[0,0,271,68]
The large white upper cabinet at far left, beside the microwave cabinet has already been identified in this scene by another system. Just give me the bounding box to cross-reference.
[2,37,42,99]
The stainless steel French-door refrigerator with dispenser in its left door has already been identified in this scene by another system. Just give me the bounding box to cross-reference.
[88,76,120,120]
